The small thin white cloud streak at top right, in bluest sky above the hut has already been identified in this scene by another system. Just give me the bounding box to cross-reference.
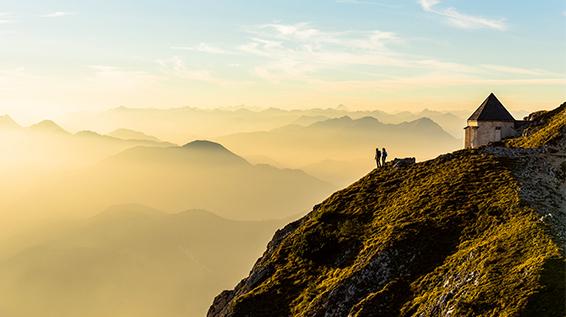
[419,0,507,31]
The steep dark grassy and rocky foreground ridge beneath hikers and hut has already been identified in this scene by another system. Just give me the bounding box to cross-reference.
[208,105,566,317]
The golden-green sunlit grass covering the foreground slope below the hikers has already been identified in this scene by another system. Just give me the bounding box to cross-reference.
[224,151,560,316]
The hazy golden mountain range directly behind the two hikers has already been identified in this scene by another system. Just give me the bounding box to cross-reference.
[218,116,461,186]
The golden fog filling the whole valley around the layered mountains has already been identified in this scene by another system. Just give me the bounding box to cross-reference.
[0,108,461,317]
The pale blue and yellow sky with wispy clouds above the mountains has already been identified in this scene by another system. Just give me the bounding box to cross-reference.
[0,0,566,120]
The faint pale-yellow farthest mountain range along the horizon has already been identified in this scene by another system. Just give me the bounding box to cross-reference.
[58,106,474,144]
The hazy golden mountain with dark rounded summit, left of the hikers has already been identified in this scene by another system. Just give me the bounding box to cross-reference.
[10,141,335,223]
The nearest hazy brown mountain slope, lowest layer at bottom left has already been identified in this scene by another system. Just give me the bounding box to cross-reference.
[0,205,286,317]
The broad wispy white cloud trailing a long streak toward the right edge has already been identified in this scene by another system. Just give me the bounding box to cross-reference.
[238,21,561,87]
